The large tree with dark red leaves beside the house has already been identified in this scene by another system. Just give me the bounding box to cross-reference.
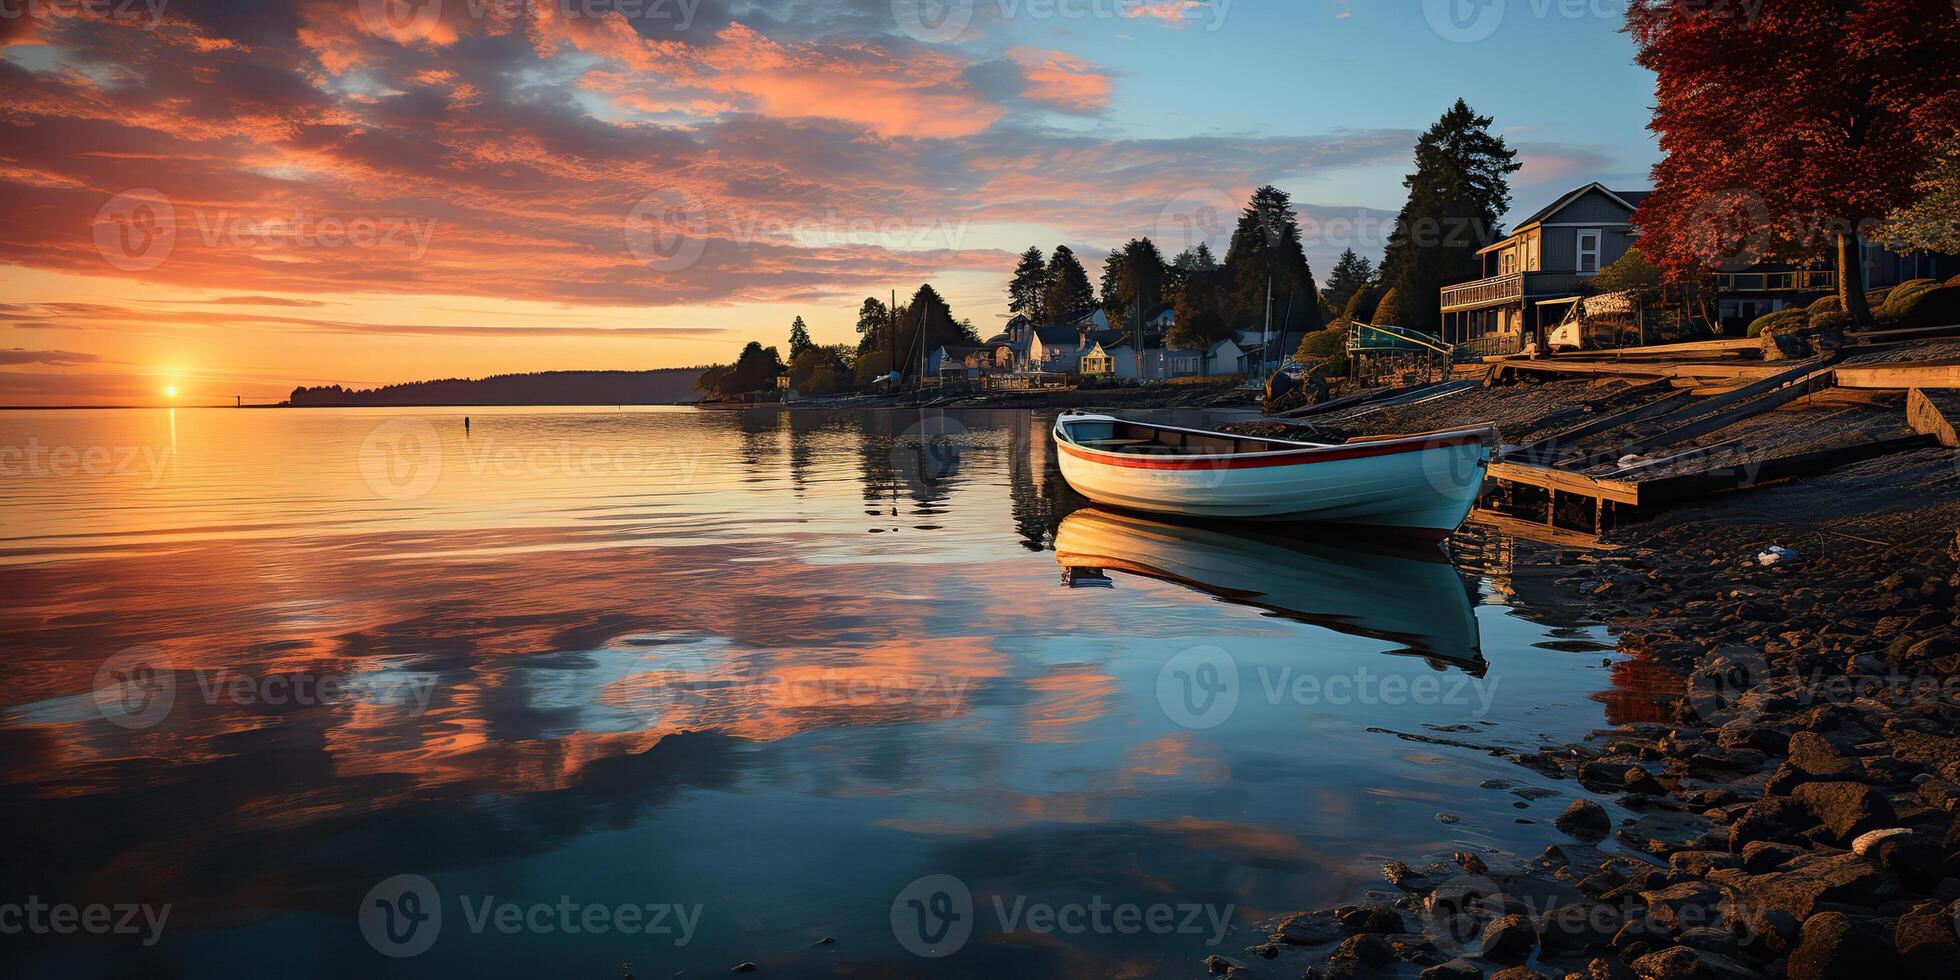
[1627,0,1960,323]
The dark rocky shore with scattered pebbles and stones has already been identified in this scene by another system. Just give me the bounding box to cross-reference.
[1205,435,1960,980]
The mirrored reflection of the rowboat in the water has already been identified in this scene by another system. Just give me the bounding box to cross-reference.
[1054,508,1486,676]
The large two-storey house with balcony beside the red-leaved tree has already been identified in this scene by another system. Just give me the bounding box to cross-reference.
[1443,180,1648,353]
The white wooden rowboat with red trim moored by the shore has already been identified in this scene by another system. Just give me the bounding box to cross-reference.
[1054,414,1497,535]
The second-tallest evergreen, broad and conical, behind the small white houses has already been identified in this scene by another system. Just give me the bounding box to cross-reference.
[1225,186,1321,335]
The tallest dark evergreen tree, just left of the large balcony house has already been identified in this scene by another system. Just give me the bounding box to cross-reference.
[1382,98,1523,333]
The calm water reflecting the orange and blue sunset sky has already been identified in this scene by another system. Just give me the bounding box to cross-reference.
[0,410,1638,978]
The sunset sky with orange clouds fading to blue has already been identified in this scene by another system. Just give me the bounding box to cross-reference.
[0,0,1656,406]
